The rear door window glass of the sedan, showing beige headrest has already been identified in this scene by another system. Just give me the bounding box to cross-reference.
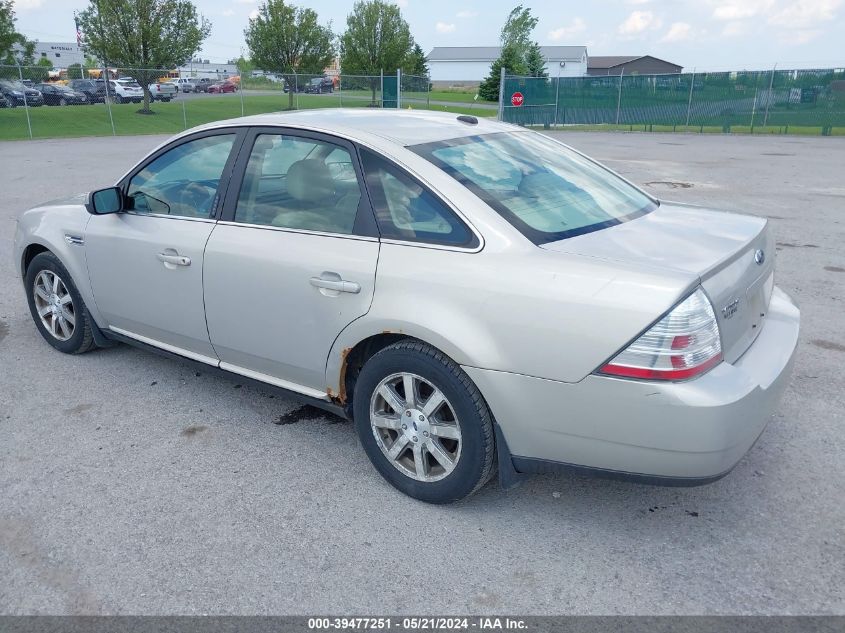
[235,134,361,234]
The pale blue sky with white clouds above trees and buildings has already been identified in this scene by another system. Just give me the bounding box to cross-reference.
[15,0,845,71]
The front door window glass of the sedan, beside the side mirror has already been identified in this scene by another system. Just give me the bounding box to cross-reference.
[126,134,235,218]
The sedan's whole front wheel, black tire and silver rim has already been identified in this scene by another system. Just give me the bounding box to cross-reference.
[26,252,96,354]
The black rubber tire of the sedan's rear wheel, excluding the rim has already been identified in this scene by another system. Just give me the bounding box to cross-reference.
[353,339,496,504]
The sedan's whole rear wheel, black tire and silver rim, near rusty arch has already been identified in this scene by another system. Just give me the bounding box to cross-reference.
[354,340,495,503]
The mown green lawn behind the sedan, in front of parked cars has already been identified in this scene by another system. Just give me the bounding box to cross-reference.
[0,93,496,141]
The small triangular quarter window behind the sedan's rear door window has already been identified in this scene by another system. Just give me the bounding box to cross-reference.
[361,150,473,246]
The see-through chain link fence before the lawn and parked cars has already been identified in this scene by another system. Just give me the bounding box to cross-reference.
[0,65,430,141]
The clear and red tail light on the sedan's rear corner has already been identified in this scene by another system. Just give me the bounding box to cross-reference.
[599,288,722,380]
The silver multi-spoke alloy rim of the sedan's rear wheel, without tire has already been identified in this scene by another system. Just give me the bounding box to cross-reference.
[370,372,462,482]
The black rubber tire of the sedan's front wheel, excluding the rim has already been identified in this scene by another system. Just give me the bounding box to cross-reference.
[25,251,97,354]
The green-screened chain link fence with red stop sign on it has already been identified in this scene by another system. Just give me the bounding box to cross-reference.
[499,69,845,136]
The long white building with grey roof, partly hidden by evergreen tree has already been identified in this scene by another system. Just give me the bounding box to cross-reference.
[427,46,587,86]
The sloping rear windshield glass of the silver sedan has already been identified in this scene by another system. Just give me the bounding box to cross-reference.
[408,132,657,244]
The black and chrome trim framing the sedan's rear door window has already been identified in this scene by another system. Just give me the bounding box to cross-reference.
[218,126,380,239]
